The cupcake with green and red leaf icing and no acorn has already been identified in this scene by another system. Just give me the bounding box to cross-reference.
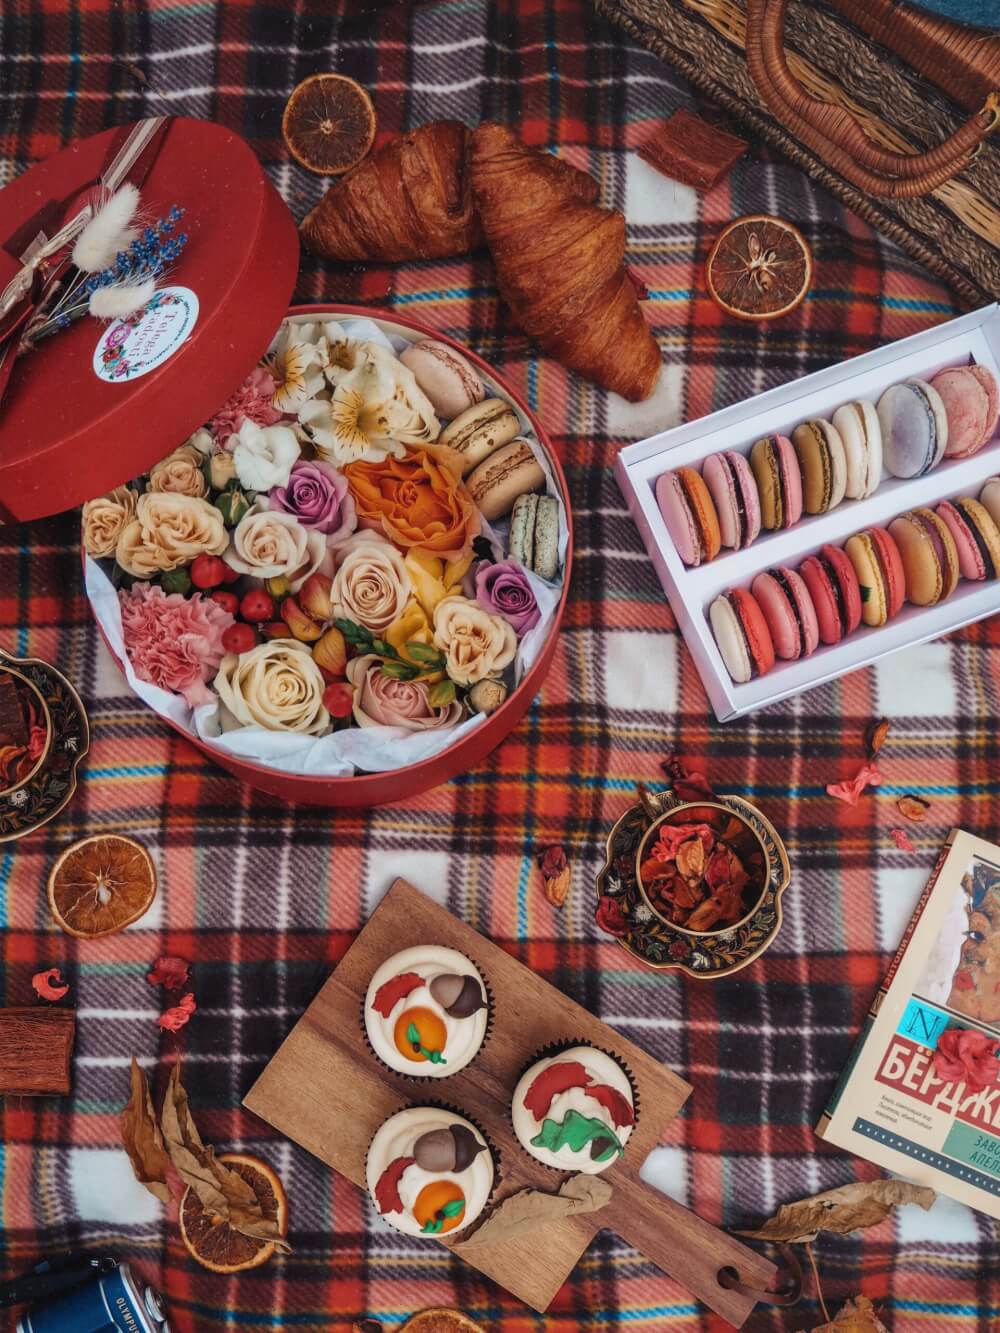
[511,1046,636,1176]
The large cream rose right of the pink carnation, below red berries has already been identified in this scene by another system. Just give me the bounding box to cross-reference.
[213,639,329,736]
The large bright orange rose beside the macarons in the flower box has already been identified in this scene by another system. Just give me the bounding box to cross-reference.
[344,445,479,560]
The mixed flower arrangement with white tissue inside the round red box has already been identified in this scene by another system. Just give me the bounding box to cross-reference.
[83,320,568,777]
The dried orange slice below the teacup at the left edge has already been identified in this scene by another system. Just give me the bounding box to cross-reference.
[48,833,156,940]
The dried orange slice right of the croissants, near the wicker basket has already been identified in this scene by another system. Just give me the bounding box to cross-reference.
[705,213,812,320]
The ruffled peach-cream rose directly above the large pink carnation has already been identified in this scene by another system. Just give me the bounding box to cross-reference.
[115,491,229,579]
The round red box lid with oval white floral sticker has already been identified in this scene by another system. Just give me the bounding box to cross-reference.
[0,117,299,523]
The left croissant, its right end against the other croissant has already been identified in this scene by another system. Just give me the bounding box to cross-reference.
[301,120,483,263]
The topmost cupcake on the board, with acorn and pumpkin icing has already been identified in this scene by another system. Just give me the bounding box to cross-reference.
[364,944,489,1078]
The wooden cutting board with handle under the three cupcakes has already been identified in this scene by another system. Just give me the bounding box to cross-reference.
[244,880,775,1328]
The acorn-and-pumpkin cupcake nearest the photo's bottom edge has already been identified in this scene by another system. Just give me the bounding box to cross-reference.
[365,1106,495,1236]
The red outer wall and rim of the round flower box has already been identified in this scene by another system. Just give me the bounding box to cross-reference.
[90,305,573,806]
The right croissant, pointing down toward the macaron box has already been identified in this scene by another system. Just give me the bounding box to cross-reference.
[471,123,661,403]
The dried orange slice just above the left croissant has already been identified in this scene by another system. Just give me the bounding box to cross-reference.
[281,75,375,176]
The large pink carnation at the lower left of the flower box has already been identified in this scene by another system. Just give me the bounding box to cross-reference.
[119,583,233,708]
